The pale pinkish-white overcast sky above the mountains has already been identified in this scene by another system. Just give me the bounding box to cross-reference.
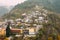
[0,0,26,6]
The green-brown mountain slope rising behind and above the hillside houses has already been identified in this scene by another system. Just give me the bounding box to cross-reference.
[4,0,60,19]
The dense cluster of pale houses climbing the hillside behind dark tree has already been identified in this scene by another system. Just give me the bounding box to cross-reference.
[0,6,48,37]
